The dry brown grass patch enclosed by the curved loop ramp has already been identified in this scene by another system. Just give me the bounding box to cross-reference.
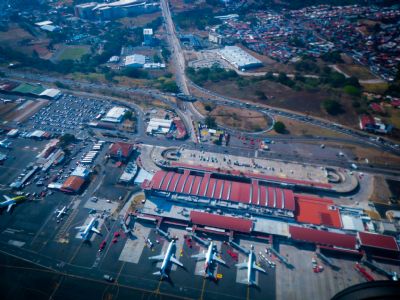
[194,101,269,131]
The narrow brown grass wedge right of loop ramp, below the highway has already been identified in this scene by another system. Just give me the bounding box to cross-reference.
[268,116,349,138]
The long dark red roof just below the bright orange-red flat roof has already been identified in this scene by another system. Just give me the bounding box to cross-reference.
[289,226,356,249]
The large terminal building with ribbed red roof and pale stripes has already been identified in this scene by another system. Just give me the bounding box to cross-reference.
[142,169,295,218]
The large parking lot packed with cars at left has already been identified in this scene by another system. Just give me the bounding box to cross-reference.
[26,95,113,134]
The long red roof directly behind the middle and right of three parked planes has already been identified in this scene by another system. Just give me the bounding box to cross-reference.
[190,210,253,233]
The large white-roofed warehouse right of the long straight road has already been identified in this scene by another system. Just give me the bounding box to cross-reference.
[219,46,262,70]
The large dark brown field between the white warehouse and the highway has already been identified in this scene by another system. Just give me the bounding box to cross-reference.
[204,80,358,127]
